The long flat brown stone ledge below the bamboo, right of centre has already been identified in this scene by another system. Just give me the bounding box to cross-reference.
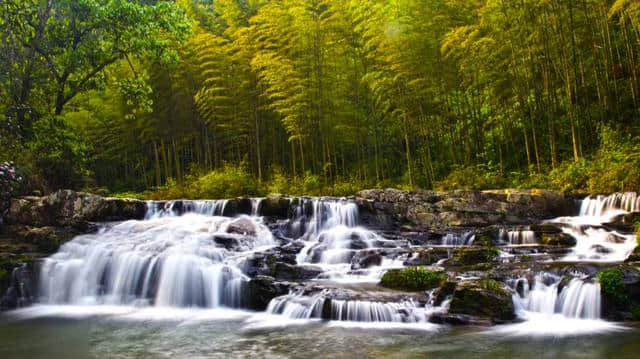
[356,189,575,231]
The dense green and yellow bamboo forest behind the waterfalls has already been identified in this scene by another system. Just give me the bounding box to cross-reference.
[0,0,640,197]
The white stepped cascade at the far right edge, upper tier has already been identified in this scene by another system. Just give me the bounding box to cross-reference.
[549,193,640,262]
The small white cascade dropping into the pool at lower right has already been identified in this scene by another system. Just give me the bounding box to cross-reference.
[513,274,601,319]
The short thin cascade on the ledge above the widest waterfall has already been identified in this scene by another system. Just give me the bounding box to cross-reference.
[145,199,229,220]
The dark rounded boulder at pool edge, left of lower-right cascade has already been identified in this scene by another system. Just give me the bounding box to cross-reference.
[449,279,515,323]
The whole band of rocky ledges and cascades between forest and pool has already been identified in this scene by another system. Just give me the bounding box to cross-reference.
[0,189,640,325]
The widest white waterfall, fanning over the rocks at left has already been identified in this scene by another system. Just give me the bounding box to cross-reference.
[40,214,274,308]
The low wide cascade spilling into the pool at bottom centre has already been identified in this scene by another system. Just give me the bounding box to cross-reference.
[267,292,440,323]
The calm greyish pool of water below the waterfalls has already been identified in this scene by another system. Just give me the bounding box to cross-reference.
[0,307,640,359]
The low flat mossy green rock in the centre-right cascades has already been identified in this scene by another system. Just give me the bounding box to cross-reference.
[380,267,447,291]
